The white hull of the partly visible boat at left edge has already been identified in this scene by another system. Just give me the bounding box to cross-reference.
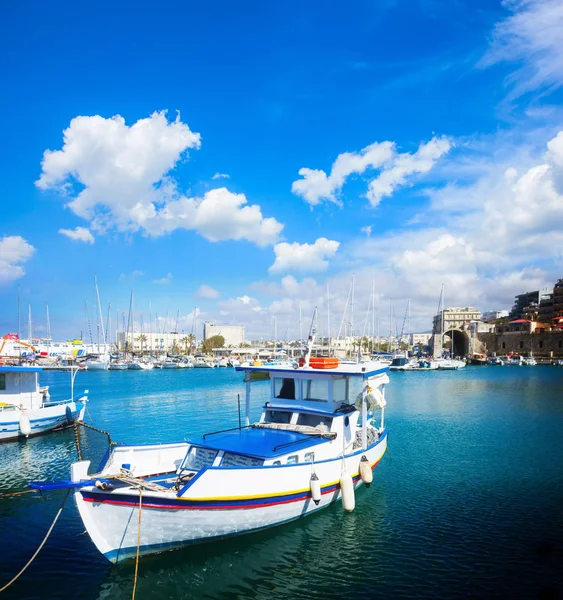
[0,400,86,442]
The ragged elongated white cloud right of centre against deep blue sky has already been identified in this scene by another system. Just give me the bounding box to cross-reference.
[291,137,451,206]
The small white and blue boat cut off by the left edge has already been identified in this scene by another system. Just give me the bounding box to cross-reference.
[0,366,88,442]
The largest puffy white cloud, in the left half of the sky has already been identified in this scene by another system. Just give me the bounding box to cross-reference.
[36,112,283,246]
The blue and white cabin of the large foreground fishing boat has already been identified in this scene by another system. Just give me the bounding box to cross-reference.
[172,363,389,473]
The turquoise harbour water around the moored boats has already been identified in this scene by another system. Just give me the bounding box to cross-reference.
[0,366,563,600]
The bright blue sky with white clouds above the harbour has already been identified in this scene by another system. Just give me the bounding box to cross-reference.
[0,0,563,337]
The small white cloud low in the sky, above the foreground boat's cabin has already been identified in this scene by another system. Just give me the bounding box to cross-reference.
[268,238,340,273]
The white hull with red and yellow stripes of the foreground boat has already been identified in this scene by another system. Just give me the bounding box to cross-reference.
[74,432,387,563]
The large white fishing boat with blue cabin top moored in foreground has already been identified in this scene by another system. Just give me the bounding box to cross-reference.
[30,338,389,563]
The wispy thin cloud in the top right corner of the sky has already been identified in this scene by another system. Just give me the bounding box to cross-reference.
[479,0,563,99]
